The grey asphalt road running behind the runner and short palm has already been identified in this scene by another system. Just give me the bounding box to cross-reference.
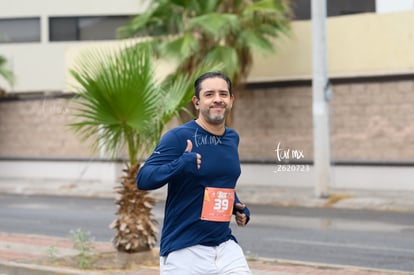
[0,194,414,271]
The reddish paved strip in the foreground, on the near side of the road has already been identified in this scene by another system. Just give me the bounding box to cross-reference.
[0,233,410,275]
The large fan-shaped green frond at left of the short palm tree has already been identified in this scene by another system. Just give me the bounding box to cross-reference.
[70,41,160,162]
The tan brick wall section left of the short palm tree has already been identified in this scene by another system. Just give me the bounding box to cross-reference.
[0,97,96,158]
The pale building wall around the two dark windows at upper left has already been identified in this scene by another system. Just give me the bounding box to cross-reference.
[0,0,149,93]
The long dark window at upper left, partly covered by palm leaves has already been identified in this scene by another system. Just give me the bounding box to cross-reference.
[49,16,130,41]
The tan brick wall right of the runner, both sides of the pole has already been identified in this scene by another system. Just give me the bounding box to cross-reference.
[233,79,414,162]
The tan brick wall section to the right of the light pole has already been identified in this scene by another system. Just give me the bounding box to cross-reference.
[332,80,414,162]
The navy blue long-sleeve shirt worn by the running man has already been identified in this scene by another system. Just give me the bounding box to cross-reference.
[137,120,250,256]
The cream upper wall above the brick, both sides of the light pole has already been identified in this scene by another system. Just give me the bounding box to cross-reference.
[249,11,414,82]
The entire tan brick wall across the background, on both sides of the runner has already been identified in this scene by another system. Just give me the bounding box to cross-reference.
[0,77,414,162]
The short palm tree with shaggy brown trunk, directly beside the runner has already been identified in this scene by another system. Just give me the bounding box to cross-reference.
[70,43,217,253]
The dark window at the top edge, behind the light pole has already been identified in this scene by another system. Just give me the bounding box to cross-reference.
[291,0,375,20]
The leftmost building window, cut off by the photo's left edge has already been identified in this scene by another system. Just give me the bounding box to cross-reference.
[0,18,40,43]
